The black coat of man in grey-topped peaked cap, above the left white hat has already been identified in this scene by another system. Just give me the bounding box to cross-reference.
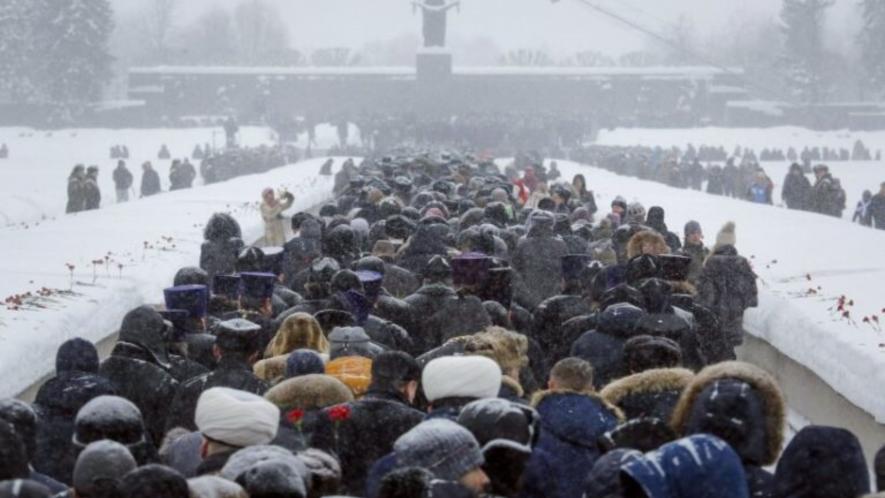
[165,357,268,430]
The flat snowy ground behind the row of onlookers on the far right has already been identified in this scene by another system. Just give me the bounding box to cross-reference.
[596,126,885,219]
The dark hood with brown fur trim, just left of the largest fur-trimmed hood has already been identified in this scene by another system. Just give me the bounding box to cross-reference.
[599,368,694,420]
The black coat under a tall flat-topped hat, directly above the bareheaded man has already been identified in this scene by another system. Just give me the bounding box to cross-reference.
[531,294,593,363]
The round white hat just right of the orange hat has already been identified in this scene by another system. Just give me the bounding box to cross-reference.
[421,356,501,403]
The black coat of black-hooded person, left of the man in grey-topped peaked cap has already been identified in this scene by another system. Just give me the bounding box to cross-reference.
[99,342,178,447]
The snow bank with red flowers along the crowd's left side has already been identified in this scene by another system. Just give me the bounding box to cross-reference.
[0,158,342,398]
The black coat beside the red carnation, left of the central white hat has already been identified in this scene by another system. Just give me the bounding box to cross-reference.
[311,390,424,496]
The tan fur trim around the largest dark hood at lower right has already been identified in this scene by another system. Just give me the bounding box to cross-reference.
[670,361,786,465]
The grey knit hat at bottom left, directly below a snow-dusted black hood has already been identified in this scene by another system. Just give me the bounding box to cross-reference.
[73,439,138,496]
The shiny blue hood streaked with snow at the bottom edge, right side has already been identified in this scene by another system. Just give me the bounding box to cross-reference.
[621,434,750,498]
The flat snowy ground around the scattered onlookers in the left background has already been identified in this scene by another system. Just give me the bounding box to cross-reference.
[0,124,359,227]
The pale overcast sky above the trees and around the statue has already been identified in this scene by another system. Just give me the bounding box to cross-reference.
[112,0,857,55]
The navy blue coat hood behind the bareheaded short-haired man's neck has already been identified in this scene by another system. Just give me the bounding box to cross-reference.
[532,389,624,448]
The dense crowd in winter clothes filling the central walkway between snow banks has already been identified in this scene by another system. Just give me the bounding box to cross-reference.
[0,149,885,498]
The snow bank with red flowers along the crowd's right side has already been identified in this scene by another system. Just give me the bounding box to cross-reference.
[544,161,885,422]
